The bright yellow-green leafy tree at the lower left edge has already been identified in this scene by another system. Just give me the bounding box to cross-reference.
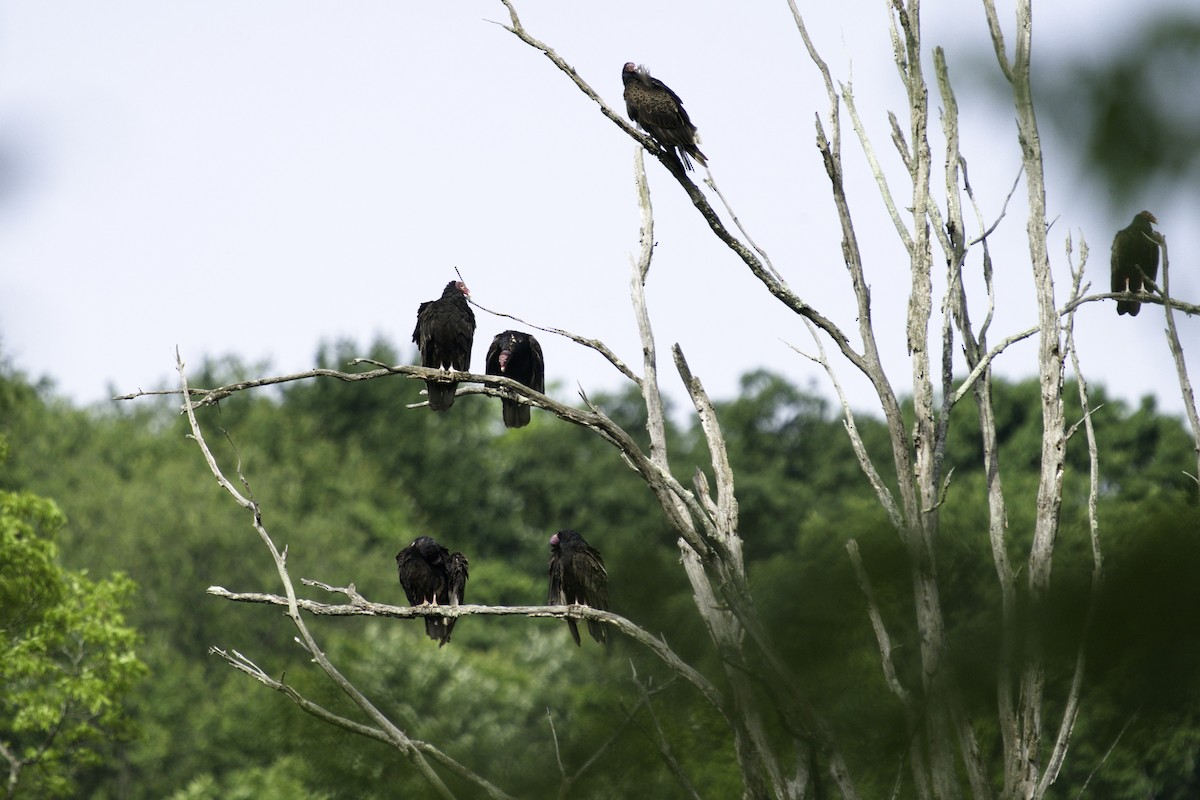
[0,438,145,798]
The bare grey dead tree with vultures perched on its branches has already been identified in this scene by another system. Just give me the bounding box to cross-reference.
[126,0,1200,800]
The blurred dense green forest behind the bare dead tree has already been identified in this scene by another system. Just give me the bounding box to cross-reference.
[0,342,1200,800]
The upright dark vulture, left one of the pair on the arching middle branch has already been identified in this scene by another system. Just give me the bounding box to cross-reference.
[413,281,475,411]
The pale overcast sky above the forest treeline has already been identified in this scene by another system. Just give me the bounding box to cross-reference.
[0,0,1200,422]
